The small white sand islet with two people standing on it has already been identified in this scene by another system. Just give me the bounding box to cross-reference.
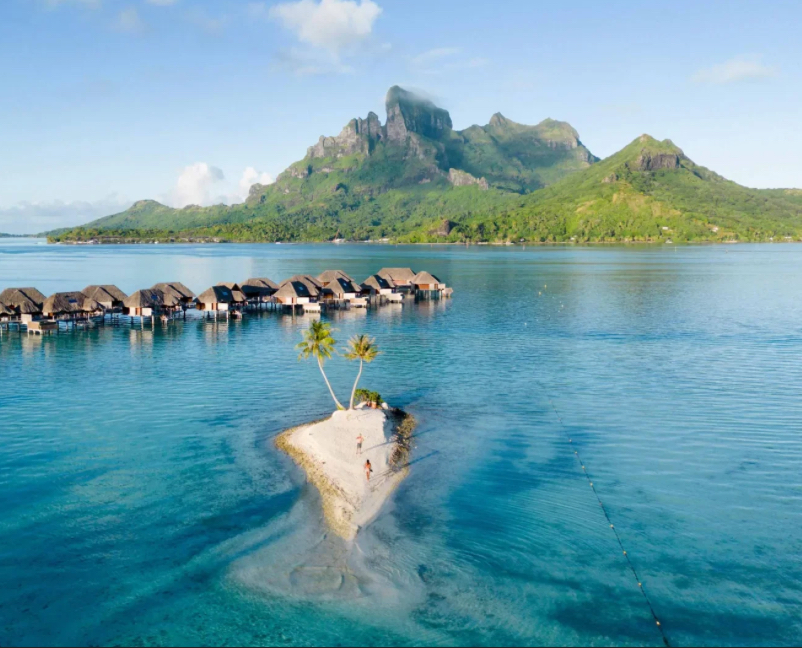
[276,409,414,540]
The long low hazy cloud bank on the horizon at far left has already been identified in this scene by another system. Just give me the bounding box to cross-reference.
[0,194,133,234]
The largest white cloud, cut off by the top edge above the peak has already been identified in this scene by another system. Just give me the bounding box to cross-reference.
[268,0,382,56]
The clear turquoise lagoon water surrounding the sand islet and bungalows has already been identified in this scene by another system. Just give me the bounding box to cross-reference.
[0,241,802,646]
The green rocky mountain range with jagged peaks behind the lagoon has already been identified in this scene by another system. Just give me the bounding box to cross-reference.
[51,87,802,242]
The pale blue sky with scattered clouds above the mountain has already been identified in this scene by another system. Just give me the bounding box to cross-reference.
[0,0,802,233]
